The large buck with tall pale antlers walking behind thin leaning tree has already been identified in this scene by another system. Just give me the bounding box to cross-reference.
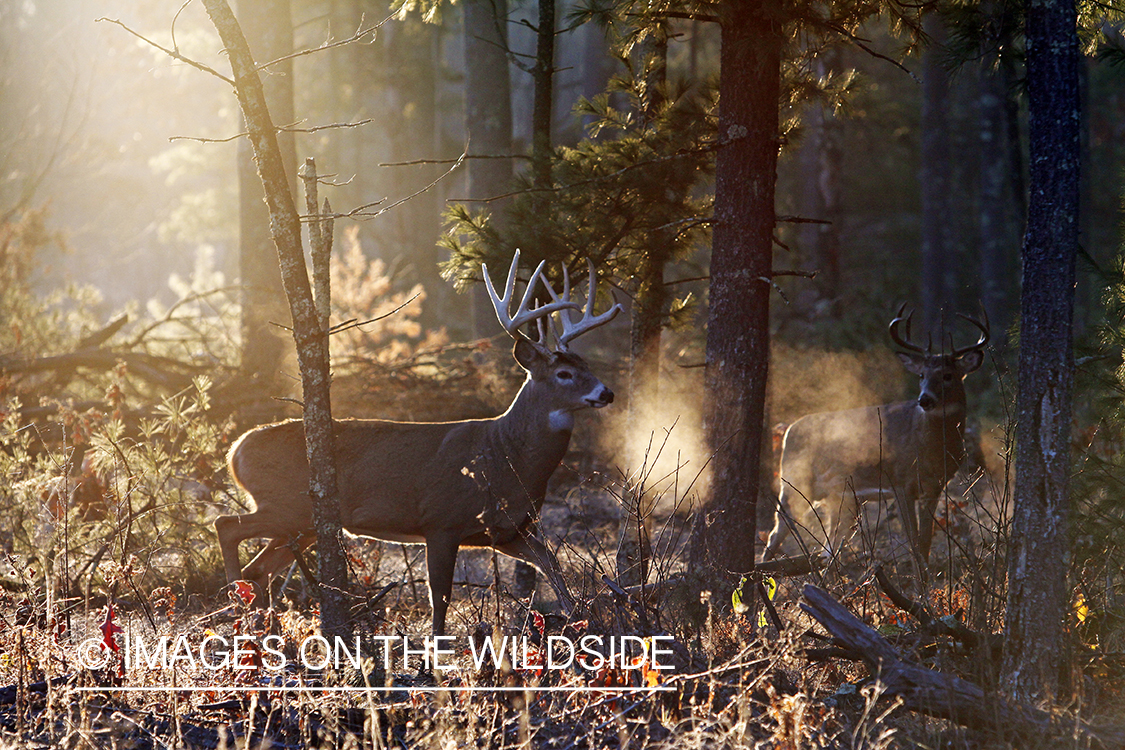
[215,252,621,635]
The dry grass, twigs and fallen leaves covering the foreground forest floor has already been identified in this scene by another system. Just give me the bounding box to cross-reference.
[0,458,1125,750]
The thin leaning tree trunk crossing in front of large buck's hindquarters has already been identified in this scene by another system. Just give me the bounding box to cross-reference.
[204,0,349,639]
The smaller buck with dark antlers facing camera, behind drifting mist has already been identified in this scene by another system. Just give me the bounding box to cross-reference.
[763,305,989,563]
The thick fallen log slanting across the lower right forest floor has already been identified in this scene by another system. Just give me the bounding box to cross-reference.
[801,584,1125,748]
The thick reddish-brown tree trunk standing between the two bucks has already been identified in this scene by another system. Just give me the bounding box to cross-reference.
[692,0,782,580]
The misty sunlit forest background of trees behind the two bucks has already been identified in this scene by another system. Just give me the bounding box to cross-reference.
[0,0,1125,746]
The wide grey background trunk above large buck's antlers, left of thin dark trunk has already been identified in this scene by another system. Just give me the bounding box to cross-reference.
[462,0,512,338]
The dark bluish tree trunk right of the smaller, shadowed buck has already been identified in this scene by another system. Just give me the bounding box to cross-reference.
[1004,0,1079,701]
